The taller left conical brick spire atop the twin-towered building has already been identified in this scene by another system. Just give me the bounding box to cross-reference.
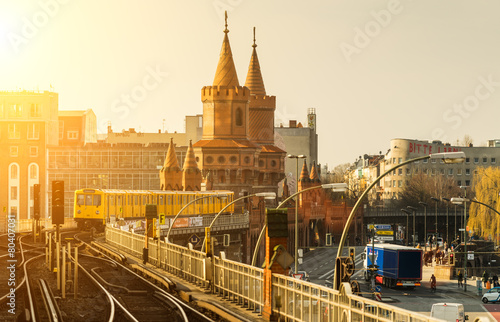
[213,11,240,86]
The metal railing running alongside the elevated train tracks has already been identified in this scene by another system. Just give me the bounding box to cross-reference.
[106,226,442,322]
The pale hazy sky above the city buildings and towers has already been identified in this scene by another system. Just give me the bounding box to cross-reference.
[0,0,500,167]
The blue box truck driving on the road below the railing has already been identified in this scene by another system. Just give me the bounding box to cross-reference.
[363,244,423,288]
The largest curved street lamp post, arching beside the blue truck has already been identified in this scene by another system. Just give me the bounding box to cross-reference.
[333,151,465,290]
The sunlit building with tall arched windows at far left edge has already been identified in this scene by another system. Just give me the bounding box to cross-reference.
[0,91,59,219]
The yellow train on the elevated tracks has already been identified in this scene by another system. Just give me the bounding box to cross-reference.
[74,189,234,229]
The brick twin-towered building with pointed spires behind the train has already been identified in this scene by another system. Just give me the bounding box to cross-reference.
[160,14,286,196]
